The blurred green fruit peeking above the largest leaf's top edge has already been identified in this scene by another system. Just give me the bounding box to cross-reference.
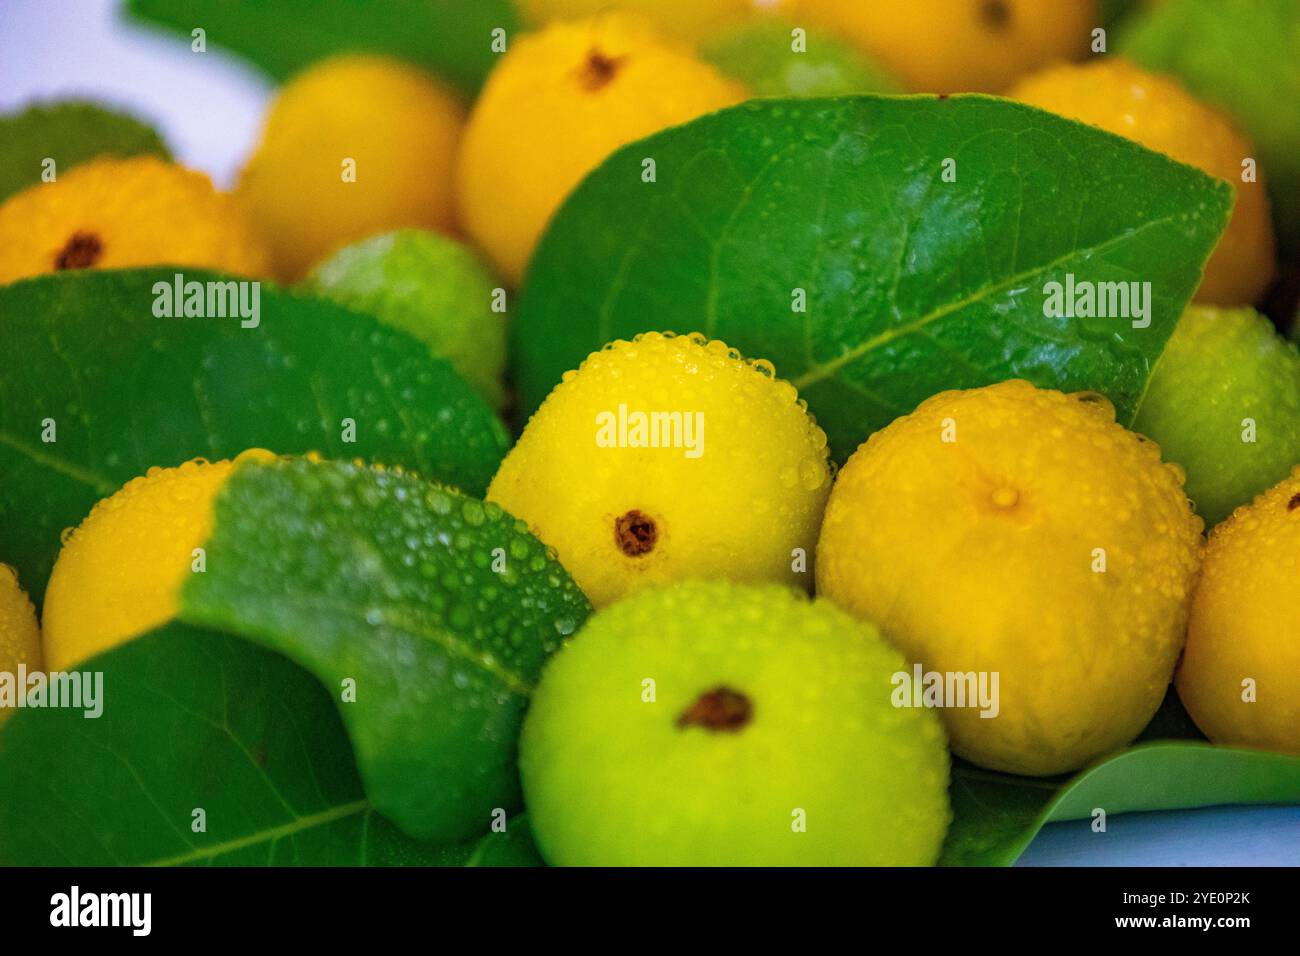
[701,21,902,96]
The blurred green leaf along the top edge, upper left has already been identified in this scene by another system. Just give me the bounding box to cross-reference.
[127,0,517,94]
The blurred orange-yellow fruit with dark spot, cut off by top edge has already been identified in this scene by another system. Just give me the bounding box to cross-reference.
[781,0,1100,92]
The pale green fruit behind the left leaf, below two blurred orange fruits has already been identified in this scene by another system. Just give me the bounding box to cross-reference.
[304,229,506,410]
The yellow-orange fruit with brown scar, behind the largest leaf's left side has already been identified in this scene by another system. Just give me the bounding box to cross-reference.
[456,14,745,285]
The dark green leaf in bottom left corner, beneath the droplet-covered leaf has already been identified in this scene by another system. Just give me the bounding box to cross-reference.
[0,624,540,866]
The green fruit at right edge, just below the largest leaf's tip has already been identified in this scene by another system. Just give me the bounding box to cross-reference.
[1134,306,1300,524]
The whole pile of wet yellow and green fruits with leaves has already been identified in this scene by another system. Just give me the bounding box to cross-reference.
[0,0,1300,865]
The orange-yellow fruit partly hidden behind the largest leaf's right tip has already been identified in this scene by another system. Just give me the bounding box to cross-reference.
[1008,57,1274,306]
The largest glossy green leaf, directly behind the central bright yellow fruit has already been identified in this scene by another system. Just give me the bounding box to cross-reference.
[515,95,1232,458]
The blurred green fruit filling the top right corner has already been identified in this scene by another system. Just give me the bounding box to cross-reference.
[1115,0,1300,255]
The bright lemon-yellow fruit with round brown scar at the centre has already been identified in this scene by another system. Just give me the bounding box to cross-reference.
[488,333,831,607]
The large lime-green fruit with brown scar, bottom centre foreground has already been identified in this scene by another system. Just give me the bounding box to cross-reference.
[520,581,949,866]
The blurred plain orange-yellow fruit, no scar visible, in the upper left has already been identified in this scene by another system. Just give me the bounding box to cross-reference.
[239,54,467,280]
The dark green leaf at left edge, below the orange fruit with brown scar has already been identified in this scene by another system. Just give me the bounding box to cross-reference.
[0,269,506,605]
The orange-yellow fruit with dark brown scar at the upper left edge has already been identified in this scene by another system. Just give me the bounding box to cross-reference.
[0,156,268,282]
